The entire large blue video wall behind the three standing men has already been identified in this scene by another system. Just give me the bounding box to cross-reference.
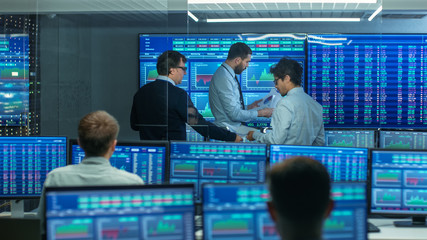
[139,34,427,128]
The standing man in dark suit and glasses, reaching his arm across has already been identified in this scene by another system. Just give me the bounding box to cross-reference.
[130,51,242,142]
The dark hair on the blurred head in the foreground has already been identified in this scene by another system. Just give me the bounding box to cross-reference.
[268,156,331,226]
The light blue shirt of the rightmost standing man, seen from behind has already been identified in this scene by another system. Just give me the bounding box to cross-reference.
[253,87,325,146]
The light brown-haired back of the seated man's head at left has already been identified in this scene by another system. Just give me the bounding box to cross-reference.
[78,111,119,156]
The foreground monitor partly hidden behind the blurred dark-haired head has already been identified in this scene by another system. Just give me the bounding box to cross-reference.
[203,182,367,240]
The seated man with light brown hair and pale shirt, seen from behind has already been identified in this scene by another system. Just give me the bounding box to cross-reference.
[38,111,144,232]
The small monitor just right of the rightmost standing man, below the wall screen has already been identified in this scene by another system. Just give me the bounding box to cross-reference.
[325,129,377,148]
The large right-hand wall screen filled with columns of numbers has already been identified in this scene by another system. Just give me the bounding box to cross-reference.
[307,35,427,128]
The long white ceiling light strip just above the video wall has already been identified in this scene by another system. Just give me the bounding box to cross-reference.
[206,18,360,23]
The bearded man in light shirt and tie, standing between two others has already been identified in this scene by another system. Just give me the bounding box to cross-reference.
[209,42,273,128]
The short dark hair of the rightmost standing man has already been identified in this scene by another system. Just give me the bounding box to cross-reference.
[270,57,302,86]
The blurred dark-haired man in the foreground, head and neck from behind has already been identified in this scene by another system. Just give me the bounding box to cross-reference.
[267,157,334,240]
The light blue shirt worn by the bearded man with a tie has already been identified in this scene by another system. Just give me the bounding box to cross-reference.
[209,63,258,127]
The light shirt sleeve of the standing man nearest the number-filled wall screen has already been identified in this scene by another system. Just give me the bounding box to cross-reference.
[253,102,292,144]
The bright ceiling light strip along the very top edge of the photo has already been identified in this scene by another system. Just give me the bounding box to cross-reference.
[188,0,377,4]
